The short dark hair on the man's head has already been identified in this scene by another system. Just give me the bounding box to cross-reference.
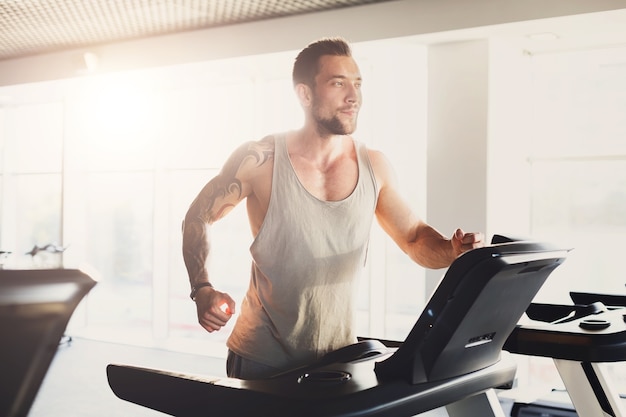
[292,37,352,87]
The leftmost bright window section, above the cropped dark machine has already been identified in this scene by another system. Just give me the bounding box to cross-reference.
[0,101,64,267]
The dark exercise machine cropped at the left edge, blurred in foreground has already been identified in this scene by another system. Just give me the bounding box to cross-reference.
[0,269,96,417]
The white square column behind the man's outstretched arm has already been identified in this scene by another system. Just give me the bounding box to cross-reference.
[426,40,489,294]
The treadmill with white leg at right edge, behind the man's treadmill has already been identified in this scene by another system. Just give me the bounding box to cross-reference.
[504,292,626,417]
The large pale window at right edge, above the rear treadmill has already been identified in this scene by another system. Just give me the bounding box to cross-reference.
[529,48,626,302]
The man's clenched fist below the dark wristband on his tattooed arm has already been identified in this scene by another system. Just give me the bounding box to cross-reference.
[196,287,235,332]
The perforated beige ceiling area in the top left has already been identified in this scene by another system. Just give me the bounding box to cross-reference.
[0,0,389,60]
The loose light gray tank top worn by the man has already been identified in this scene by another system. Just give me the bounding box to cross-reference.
[227,134,378,369]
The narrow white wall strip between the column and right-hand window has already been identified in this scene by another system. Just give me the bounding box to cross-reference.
[486,41,533,237]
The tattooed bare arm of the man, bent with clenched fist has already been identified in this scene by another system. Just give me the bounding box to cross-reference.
[183,138,274,332]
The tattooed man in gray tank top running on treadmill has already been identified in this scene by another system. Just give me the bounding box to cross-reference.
[183,38,483,379]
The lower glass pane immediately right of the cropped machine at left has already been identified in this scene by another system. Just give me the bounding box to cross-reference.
[81,173,153,337]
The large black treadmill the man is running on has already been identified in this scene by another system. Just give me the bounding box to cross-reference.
[107,236,567,417]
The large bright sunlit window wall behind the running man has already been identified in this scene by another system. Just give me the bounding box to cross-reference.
[0,43,426,354]
